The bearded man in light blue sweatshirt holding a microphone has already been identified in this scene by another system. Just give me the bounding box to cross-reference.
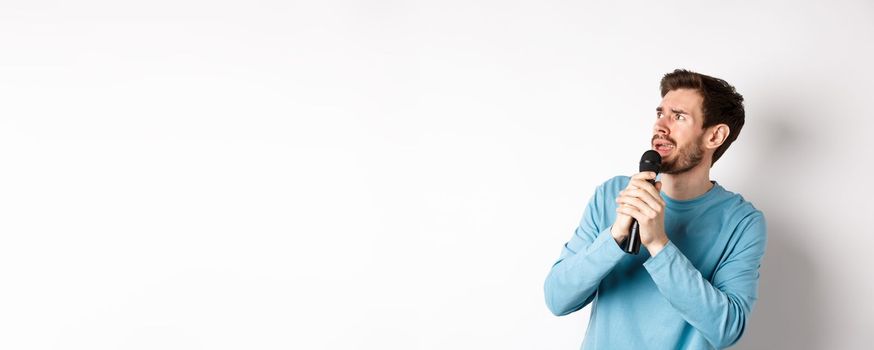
[544,70,766,350]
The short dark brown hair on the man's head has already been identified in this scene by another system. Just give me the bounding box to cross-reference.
[661,69,744,167]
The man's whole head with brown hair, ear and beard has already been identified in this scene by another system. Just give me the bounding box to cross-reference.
[652,69,744,174]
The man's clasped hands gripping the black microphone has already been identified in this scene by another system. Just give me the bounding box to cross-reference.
[610,171,668,256]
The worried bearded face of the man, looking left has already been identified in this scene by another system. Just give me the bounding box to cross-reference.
[652,89,704,174]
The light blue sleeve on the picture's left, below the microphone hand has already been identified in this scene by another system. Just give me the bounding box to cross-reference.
[544,186,625,316]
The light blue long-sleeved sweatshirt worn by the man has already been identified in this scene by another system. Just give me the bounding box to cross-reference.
[544,176,766,350]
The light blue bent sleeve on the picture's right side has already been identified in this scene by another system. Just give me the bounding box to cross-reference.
[643,213,766,348]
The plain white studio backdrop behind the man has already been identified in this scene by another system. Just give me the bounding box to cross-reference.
[0,0,874,350]
